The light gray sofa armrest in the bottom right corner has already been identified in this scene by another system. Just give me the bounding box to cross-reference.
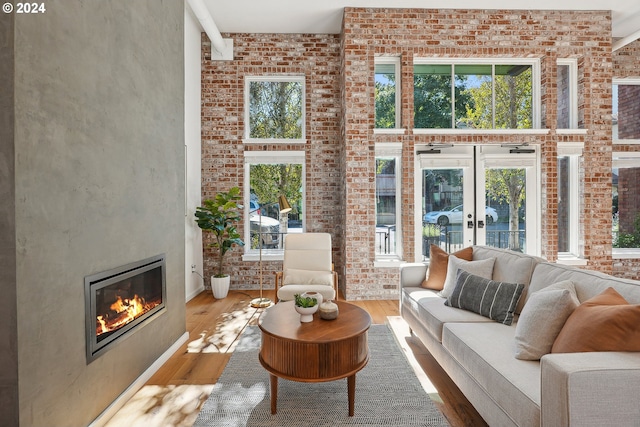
[540,352,640,427]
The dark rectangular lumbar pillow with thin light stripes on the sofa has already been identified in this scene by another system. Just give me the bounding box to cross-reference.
[445,268,524,325]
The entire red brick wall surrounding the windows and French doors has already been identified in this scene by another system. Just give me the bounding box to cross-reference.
[202,8,640,299]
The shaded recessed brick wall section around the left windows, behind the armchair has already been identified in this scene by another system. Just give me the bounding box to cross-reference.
[202,34,344,289]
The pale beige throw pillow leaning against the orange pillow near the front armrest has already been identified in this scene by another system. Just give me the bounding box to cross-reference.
[516,280,580,360]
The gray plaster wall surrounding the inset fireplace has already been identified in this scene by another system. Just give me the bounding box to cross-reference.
[14,0,186,427]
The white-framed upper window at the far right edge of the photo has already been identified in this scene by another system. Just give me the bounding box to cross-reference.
[612,79,640,144]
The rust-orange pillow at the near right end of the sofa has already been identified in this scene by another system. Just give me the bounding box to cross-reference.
[551,288,640,353]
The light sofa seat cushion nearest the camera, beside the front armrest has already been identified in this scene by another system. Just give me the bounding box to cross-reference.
[442,322,541,426]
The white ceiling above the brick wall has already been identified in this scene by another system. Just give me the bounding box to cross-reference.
[205,0,640,38]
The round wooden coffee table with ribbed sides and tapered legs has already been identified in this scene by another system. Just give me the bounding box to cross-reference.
[258,301,371,416]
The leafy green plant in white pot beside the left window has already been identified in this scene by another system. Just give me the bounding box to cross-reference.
[195,187,244,299]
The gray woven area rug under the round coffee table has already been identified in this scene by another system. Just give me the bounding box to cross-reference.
[194,325,449,427]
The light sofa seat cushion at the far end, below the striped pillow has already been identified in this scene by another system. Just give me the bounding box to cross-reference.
[400,287,491,342]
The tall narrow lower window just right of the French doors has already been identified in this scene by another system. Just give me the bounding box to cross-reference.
[556,143,583,261]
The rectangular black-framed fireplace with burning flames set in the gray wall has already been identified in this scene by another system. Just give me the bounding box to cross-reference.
[84,254,166,363]
